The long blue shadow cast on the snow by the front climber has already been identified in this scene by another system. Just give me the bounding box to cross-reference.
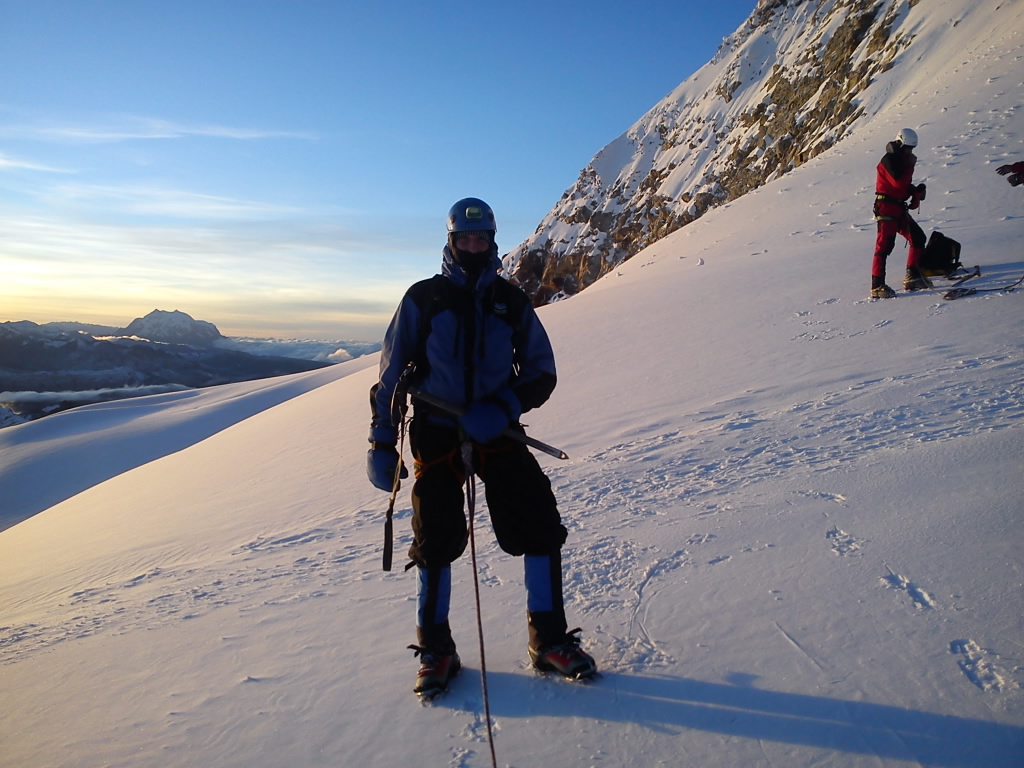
[441,669,1024,768]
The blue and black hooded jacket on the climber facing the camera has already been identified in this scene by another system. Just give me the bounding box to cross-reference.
[370,247,556,443]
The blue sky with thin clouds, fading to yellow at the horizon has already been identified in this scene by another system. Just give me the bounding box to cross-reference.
[0,0,756,340]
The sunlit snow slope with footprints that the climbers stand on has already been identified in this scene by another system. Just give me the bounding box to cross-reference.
[0,2,1024,768]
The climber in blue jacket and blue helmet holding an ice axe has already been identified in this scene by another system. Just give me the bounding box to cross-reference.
[367,198,596,694]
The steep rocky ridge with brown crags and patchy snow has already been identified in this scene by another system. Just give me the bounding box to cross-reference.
[504,0,1007,304]
